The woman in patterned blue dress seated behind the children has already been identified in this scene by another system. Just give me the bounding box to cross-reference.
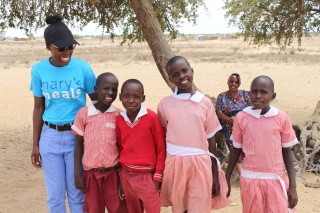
[216,73,251,175]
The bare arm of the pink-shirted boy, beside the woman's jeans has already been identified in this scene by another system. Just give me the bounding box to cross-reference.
[74,135,85,193]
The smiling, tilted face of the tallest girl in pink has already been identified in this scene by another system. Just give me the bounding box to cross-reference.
[167,58,193,94]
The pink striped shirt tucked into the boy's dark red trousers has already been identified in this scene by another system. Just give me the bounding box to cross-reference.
[72,105,120,170]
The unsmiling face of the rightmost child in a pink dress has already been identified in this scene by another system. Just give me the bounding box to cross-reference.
[250,76,276,114]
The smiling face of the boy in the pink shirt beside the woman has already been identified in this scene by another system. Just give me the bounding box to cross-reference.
[94,74,119,111]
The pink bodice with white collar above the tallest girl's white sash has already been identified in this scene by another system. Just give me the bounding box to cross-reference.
[158,91,221,151]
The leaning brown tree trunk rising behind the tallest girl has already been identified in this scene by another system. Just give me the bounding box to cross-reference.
[130,0,174,90]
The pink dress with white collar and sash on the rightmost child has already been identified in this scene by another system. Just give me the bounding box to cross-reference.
[232,106,298,213]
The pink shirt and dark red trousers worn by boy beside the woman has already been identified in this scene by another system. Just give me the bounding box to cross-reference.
[72,105,125,213]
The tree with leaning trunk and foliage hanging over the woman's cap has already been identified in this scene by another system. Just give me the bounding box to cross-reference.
[0,0,205,89]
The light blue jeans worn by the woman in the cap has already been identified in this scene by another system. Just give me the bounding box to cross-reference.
[39,124,84,213]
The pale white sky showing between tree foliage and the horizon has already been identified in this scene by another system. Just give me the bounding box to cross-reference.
[5,0,238,37]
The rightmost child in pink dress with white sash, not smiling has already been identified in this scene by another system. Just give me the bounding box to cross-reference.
[226,76,298,213]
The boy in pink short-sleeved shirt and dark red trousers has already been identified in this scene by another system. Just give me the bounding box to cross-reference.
[72,73,127,213]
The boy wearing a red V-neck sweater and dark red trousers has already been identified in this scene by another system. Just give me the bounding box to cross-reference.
[116,79,166,213]
